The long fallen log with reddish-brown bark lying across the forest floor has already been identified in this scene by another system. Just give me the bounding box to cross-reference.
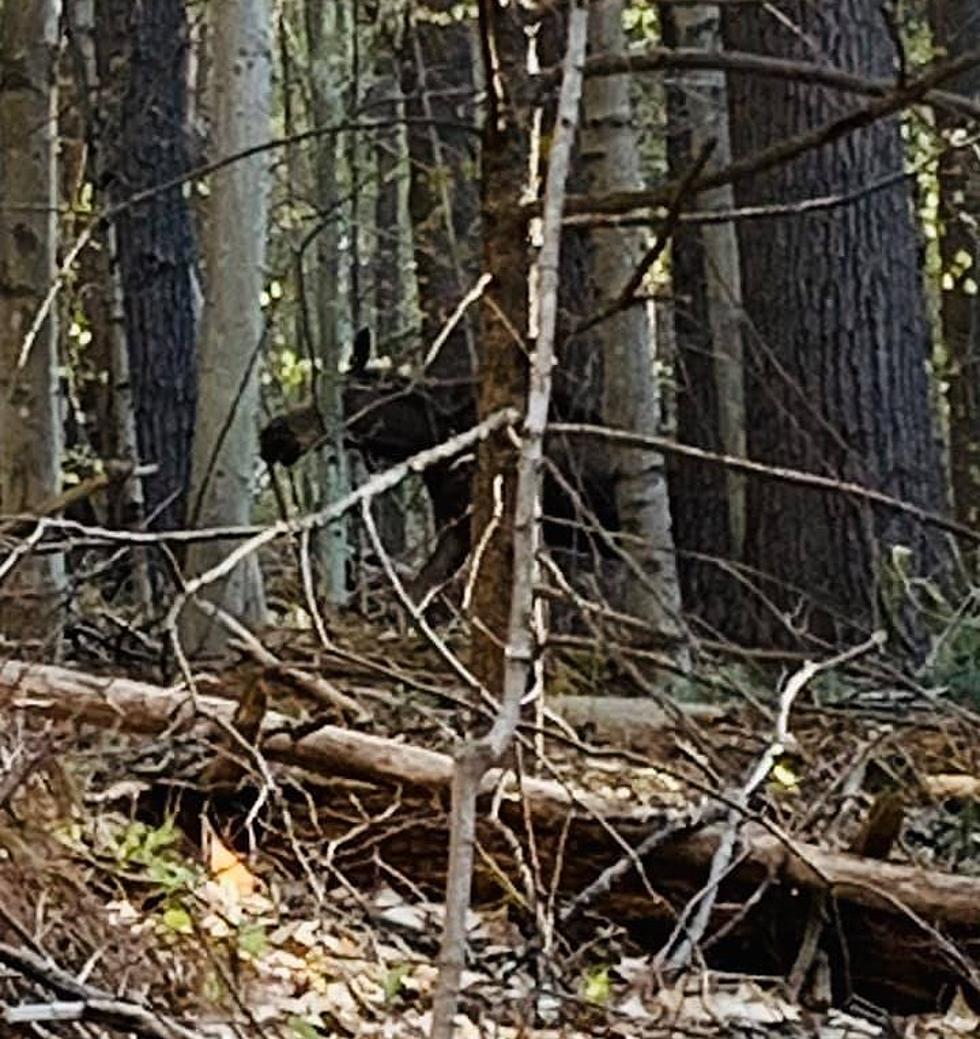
[0,661,980,929]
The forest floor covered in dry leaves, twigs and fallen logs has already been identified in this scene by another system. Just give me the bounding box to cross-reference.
[0,602,980,1039]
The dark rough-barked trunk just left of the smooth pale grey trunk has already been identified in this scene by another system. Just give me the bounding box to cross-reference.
[96,0,196,529]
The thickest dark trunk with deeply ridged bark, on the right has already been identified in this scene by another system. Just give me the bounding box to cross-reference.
[725,0,944,641]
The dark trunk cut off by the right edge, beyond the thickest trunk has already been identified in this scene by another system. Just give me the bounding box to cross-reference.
[930,0,980,527]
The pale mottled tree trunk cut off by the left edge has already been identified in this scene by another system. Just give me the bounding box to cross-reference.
[0,0,64,639]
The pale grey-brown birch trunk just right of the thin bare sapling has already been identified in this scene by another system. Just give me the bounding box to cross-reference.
[582,0,686,657]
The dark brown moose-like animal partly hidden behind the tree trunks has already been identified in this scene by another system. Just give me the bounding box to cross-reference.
[260,330,618,597]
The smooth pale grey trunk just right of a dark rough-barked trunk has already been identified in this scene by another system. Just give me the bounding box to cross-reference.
[184,0,271,650]
